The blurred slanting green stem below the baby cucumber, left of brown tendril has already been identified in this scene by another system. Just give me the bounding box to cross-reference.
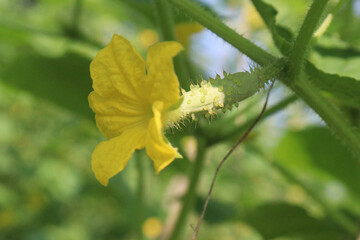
[169,137,206,240]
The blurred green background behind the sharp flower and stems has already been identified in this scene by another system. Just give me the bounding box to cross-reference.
[0,0,360,240]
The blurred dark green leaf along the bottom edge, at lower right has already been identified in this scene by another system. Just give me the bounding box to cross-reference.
[244,202,346,240]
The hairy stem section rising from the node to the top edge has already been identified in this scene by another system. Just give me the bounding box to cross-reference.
[288,0,329,82]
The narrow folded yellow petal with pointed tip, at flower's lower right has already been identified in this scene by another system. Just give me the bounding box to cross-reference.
[145,101,178,173]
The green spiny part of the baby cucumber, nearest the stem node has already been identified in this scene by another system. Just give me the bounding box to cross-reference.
[209,71,268,110]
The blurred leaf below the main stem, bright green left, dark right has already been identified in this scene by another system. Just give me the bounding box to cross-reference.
[274,127,360,194]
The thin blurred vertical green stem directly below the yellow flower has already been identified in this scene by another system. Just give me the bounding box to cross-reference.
[135,151,145,240]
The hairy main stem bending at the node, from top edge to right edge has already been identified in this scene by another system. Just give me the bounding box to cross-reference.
[281,0,360,159]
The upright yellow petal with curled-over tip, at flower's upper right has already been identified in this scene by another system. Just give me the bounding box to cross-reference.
[146,42,183,109]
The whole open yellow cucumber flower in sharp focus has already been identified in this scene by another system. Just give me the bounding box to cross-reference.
[89,35,182,186]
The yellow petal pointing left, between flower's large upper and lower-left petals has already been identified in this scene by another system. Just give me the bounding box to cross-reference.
[89,92,152,139]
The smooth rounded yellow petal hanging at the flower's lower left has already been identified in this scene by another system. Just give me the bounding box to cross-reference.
[91,128,146,186]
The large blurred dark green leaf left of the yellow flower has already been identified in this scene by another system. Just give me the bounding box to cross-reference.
[0,50,93,118]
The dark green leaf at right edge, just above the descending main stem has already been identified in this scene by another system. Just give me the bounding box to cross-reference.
[305,62,360,109]
